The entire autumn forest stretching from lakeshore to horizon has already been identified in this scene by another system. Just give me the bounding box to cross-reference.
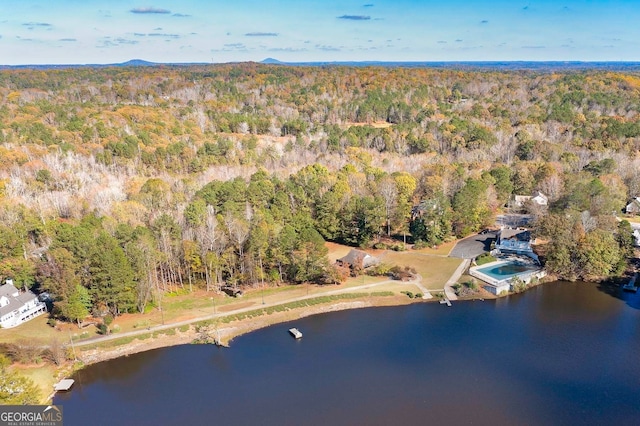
[0,63,640,320]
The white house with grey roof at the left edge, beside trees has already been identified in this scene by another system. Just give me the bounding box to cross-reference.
[0,280,47,328]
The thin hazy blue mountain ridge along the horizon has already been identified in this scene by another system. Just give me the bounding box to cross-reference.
[0,58,640,71]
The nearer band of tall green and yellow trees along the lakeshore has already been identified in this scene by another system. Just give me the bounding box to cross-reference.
[0,159,632,320]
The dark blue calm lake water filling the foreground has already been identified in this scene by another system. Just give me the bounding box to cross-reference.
[54,283,640,426]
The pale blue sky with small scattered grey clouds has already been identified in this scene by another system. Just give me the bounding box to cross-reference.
[0,0,640,65]
